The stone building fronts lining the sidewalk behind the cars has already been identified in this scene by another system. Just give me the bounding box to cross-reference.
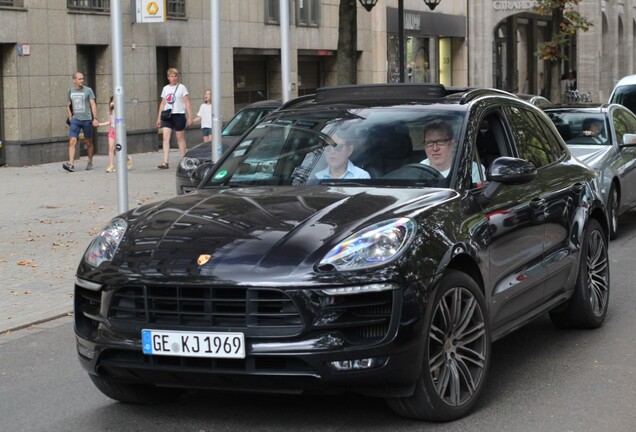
[0,0,636,166]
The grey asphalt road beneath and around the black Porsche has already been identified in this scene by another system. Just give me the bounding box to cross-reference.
[0,214,636,432]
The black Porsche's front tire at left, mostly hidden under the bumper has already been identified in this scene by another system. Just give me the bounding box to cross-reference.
[88,374,183,405]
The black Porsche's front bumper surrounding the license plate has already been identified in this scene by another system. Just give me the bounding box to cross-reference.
[75,278,426,397]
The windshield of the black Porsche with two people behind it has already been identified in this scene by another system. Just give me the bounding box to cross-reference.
[205,106,463,187]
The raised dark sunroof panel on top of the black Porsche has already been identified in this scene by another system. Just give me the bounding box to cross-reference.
[316,83,446,103]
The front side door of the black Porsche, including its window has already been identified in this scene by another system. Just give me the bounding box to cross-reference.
[476,108,546,328]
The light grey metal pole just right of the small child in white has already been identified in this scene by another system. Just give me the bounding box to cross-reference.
[210,0,222,163]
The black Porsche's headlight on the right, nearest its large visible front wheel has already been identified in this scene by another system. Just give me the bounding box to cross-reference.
[319,218,416,271]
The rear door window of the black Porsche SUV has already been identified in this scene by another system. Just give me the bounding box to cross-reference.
[505,107,562,168]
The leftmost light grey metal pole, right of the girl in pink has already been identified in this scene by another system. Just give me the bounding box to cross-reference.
[110,0,128,213]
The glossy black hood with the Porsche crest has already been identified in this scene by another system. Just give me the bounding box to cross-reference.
[113,186,456,283]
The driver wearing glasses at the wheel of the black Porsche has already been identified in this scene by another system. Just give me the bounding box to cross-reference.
[420,120,485,184]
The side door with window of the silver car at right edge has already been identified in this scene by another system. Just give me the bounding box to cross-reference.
[610,106,636,211]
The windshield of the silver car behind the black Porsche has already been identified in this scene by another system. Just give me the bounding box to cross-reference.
[547,112,609,145]
